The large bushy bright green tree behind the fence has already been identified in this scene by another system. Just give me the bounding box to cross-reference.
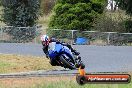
[49,0,105,31]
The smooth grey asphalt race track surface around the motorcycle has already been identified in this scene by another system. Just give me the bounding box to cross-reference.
[0,43,132,75]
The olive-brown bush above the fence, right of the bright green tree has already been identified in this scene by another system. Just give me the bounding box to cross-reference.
[93,10,129,32]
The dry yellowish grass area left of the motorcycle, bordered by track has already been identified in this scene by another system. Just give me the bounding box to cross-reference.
[0,54,55,74]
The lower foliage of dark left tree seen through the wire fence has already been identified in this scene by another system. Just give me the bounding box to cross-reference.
[5,26,37,43]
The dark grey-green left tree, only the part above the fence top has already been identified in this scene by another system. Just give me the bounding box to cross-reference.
[2,0,40,27]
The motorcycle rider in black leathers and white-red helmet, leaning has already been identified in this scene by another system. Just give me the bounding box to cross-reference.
[41,35,81,66]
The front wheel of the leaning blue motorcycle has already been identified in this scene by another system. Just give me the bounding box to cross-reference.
[60,55,76,70]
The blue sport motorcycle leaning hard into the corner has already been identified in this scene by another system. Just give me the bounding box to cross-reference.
[48,43,85,70]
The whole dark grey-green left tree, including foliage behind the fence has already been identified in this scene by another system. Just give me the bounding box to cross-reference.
[1,0,40,41]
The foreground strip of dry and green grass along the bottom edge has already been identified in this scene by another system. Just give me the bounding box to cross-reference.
[0,76,132,88]
